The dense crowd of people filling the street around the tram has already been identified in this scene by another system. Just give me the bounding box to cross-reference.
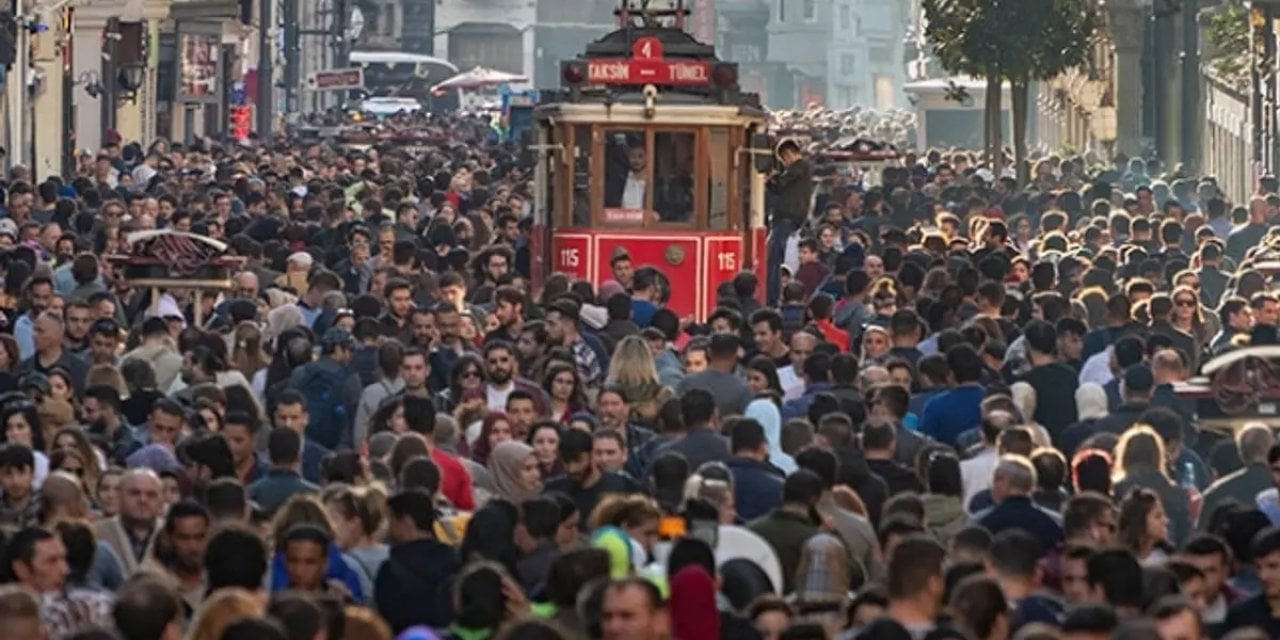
[0,115,1280,640]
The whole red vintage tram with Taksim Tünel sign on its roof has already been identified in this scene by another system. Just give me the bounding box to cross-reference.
[531,0,773,320]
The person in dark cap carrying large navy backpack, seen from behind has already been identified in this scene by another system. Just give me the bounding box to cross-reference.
[289,326,364,451]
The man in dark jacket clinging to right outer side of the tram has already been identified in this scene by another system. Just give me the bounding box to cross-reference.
[765,140,813,305]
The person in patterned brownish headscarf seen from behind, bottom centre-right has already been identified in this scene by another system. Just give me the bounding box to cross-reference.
[792,534,851,636]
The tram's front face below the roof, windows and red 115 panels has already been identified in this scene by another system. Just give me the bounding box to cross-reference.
[543,123,756,319]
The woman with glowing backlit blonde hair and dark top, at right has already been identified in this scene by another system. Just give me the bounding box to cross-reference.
[1111,424,1192,547]
